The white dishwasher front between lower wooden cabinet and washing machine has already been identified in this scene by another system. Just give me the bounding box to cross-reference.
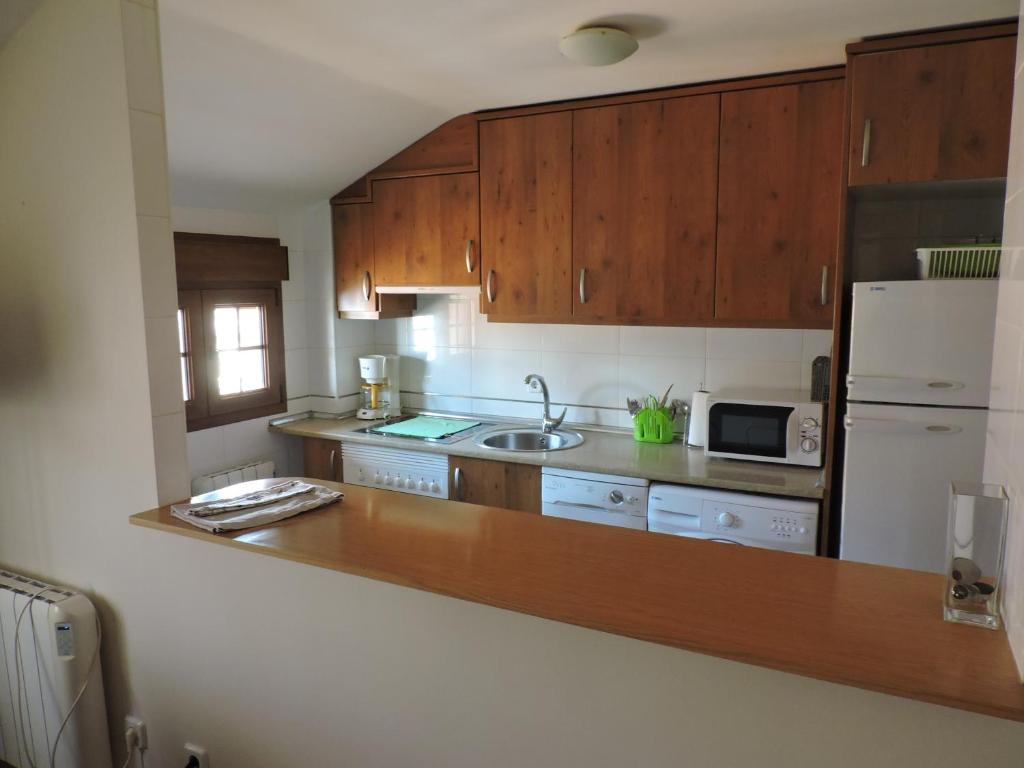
[541,467,650,530]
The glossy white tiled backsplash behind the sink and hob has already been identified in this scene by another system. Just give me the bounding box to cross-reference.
[337,296,831,427]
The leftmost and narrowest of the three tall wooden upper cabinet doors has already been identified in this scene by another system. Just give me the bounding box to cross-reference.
[480,112,572,322]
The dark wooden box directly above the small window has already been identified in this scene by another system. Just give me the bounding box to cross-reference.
[174,232,288,288]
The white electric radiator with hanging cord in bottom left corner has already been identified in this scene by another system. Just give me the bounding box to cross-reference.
[0,570,111,768]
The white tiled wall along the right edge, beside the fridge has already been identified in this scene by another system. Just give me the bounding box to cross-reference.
[985,7,1024,681]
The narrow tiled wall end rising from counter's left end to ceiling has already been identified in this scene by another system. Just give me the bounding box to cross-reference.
[121,0,188,504]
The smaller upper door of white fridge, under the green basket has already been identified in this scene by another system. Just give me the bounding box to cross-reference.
[847,280,998,408]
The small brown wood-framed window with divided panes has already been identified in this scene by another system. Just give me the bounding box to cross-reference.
[178,288,287,431]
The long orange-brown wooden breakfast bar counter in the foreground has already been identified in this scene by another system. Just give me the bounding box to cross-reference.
[131,483,1024,721]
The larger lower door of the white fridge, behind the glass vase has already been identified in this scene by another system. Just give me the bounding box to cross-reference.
[840,402,988,572]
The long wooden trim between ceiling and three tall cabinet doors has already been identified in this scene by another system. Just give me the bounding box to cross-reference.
[476,66,846,122]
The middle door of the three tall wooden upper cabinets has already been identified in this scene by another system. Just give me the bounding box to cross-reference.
[572,94,719,325]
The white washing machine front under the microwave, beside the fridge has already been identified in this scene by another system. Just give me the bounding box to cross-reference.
[647,482,818,555]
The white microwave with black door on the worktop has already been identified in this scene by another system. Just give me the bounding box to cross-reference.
[705,389,824,467]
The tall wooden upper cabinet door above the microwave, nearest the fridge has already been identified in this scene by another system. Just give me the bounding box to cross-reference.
[715,80,843,328]
